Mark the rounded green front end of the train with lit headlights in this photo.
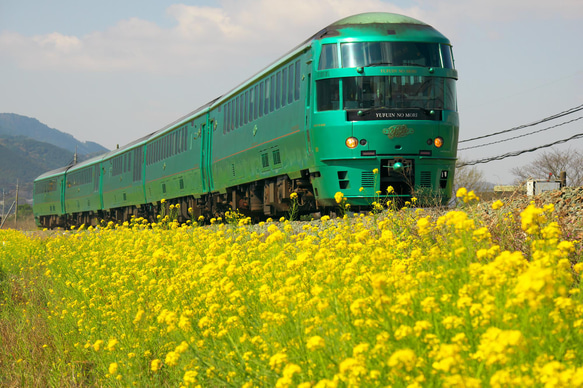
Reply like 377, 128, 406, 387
308, 13, 459, 206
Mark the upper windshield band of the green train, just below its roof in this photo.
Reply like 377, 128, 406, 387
340, 42, 453, 69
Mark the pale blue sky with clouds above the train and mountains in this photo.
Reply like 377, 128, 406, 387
0, 0, 583, 184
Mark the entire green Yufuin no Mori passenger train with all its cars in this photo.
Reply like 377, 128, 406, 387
34, 13, 459, 228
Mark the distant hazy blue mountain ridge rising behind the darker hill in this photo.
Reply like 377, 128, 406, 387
0, 113, 108, 155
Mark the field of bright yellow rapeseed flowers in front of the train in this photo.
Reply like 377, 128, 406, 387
0, 191, 583, 388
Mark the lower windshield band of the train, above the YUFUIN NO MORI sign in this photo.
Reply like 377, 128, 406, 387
317, 76, 457, 111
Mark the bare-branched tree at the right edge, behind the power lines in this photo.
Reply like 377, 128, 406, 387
510, 148, 583, 186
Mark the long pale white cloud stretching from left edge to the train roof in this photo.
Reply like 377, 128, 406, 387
0, 0, 420, 74
